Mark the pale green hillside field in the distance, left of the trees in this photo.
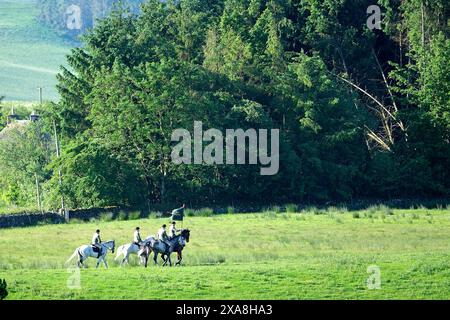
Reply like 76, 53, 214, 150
0, 0, 72, 101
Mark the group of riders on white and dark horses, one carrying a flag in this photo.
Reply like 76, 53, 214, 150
67, 205, 190, 267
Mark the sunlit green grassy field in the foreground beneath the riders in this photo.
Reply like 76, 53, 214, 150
0, 208, 450, 299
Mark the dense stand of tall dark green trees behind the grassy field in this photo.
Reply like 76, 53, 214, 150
1, 0, 450, 207
